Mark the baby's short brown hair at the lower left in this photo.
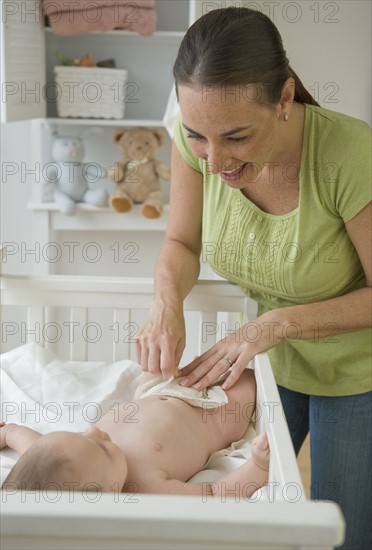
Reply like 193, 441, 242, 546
1, 445, 73, 491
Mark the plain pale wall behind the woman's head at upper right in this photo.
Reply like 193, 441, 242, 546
197, 0, 372, 123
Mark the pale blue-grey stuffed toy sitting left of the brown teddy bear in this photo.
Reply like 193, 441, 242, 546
43, 135, 108, 216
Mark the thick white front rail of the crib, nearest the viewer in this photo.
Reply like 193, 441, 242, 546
1, 492, 342, 550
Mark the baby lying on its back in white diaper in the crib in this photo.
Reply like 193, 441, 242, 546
0, 370, 269, 498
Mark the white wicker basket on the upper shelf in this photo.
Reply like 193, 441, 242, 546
54, 65, 128, 119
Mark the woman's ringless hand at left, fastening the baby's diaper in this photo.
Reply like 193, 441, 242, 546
136, 302, 186, 379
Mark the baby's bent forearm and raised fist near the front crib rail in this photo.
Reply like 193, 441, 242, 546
204, 433, 270, 500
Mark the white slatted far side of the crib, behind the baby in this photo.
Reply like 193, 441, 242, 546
1, 275, 256, 361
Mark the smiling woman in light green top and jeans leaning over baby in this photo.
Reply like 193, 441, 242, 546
137, 8, 372, 550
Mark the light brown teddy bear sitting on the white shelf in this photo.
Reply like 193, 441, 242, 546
108, 127, 170, 218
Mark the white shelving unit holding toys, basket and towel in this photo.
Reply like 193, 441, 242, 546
1, 0, 202, 275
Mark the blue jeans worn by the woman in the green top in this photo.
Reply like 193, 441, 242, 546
278, 386, 372, 550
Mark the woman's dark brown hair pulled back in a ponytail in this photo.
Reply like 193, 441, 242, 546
173, 7, 318, 105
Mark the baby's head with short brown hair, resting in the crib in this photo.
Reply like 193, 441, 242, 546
2, 427, 128, 492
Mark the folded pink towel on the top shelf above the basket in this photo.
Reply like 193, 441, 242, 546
43, 0, 157, 36
